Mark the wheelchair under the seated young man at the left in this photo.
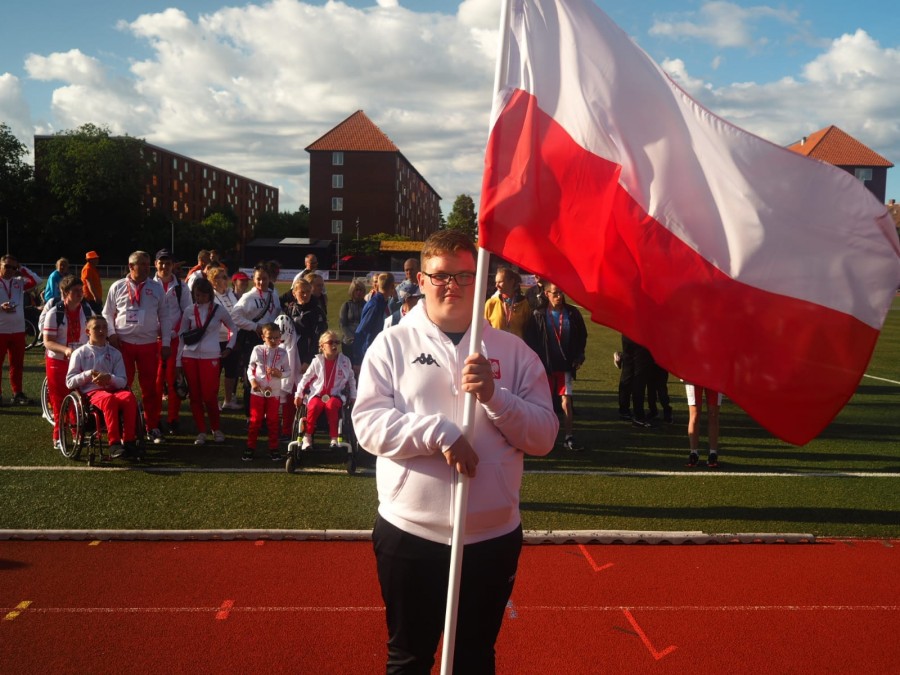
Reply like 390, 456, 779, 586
59, 391, 147, 466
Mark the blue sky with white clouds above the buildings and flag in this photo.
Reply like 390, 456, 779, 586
0, 0, 900, 214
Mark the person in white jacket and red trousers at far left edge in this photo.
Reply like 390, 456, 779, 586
0, 254, 40, 406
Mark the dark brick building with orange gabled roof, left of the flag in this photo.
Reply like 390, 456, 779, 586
306, 110, 441, 241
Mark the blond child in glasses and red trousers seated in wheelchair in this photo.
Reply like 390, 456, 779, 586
294, 330, 356, 450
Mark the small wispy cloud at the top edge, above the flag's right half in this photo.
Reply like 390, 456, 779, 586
650, 0, 796, 47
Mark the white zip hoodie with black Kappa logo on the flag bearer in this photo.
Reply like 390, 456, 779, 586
353, 303, 559, 544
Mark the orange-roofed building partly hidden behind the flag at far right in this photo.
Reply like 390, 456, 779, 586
788, 125, 894, 204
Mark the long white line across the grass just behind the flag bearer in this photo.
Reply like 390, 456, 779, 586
0, 466, 900, 478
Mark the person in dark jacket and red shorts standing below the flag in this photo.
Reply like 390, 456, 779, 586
526, 284, 587, 450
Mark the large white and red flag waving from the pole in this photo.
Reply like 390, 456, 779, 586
479, 0, 900, 444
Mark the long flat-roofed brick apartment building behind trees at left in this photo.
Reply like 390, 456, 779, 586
34, 136, 278, 252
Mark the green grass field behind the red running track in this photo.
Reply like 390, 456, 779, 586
0, 283, 900, 537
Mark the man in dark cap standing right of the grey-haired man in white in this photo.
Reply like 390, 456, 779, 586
154, 249, 191, 435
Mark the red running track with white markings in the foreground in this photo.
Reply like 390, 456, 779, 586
0, 540, 900, 675
